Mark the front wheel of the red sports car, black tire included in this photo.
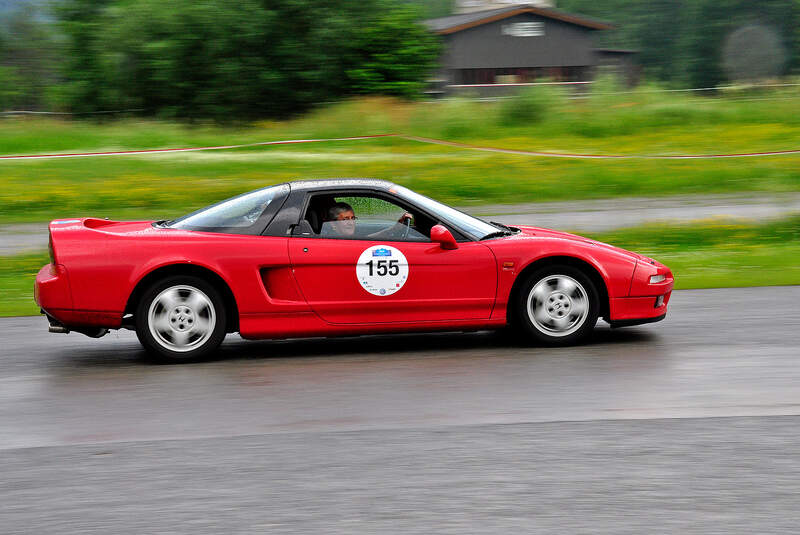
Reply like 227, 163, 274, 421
512, 265, 600, 346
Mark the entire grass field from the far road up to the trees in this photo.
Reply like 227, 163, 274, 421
0, 88, 800, 223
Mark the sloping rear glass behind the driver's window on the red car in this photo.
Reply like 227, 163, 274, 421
165, 184, 289, 230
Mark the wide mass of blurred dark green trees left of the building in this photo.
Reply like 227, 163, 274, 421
53, 0, 438, 120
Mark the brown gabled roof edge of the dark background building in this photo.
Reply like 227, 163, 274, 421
425, 4, 613, 35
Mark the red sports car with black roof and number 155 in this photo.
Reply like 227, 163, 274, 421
35, 179, 673, 361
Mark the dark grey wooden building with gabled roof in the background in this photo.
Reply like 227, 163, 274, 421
425, 0, 635, 95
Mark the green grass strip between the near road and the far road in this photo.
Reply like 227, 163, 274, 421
0, 216, 800, 316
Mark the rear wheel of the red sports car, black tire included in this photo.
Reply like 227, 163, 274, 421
135, 275, 227, 363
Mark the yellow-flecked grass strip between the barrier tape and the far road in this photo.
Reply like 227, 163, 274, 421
0, 140, 800, 223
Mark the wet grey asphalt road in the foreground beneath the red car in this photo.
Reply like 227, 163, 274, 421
0, 287, 800, 534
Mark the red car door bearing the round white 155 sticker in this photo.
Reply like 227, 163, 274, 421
289, 195, 497, 324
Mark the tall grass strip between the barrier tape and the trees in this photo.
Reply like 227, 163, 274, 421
0, 85, 800, 154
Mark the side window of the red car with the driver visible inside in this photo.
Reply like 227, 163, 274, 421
304, 194, 432, 242
